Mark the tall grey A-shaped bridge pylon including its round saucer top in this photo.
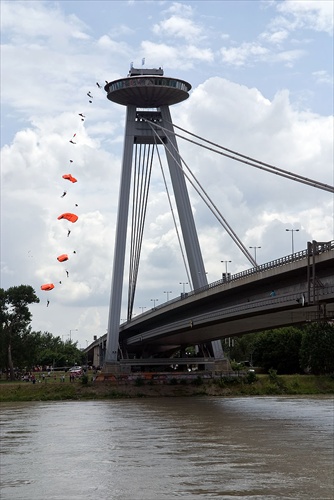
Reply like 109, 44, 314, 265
104, 67, 224, 371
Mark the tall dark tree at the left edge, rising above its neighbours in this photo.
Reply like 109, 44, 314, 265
0, 285, 39, 380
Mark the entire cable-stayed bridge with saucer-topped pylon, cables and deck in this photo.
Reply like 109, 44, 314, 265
89, 67, 334, 373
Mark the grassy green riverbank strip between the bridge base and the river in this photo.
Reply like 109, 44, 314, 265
0, 375, 334, 402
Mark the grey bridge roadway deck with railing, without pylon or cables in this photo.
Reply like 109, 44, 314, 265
86, 241, 334, 371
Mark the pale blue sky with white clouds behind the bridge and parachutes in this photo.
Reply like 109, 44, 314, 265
0, 0, 334, 347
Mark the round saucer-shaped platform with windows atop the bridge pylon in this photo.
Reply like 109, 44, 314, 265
104, 68, 191, 108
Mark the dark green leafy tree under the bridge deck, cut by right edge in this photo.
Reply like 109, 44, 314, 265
300, 322, 334, 375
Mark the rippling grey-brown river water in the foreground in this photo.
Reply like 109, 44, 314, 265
0, 397, 334, 500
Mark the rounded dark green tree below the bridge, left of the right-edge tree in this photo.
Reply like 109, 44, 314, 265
253, 326, 303, 373
